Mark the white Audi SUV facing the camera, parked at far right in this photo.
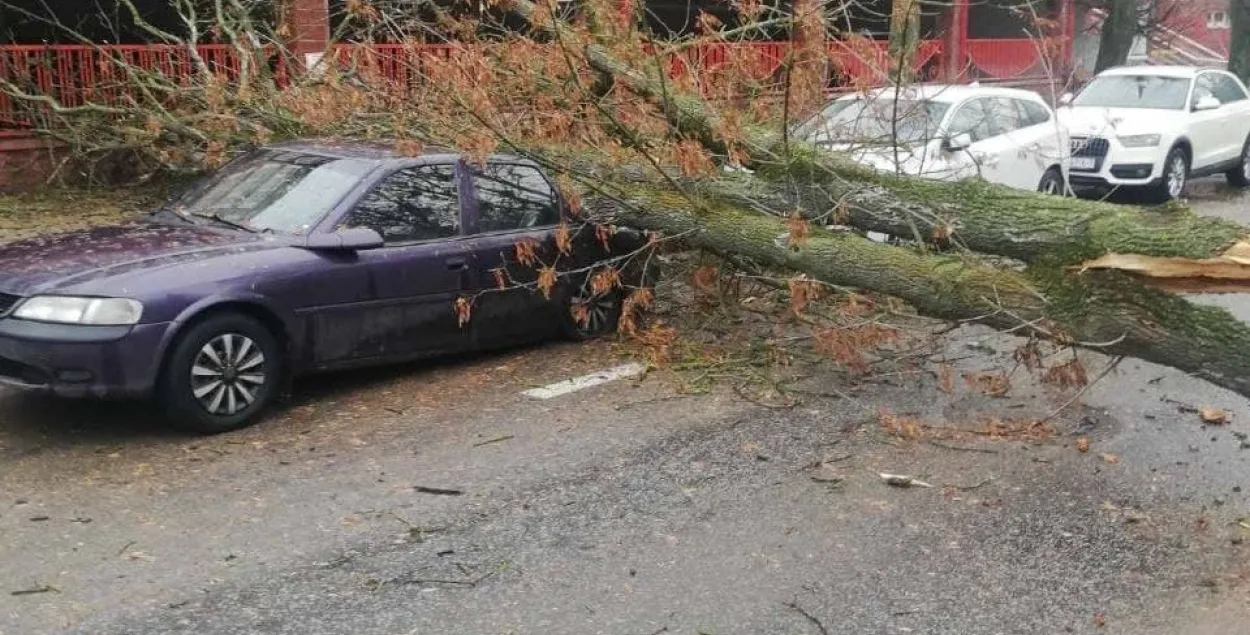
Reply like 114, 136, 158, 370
1059, 66, 1250, 199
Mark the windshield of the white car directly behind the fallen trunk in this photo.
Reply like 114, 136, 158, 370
800, 98, 950, 145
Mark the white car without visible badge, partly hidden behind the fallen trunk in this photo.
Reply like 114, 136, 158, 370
794, 84, 1069, 194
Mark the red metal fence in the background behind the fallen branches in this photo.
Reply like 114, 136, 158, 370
0, 39, 1046, 128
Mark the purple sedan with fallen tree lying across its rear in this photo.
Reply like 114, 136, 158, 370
0, 143, 654, 433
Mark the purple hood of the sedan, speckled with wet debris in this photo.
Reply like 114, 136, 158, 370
0, 220, 270, 296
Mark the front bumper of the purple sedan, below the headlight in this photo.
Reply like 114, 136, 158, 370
0, 319, 170, 398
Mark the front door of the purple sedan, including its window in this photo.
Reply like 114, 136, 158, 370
314, 163, 471, 366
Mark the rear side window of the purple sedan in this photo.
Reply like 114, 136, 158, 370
473, 164, 560, 231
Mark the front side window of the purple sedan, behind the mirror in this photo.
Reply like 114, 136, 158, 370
343, 164, 460, 245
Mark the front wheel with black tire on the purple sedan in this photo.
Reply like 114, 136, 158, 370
158, 313, 285, 434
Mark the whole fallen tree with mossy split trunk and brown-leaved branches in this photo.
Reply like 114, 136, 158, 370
7, 0, 1250, 395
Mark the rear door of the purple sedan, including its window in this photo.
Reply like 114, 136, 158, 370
466, 159, 567, 348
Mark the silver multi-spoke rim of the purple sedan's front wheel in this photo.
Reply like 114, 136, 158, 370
190, 334, 268, 416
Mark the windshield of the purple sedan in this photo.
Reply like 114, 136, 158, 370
173, 150, 374, 234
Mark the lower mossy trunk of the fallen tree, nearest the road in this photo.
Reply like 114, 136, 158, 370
584, 184, 1250, 395
